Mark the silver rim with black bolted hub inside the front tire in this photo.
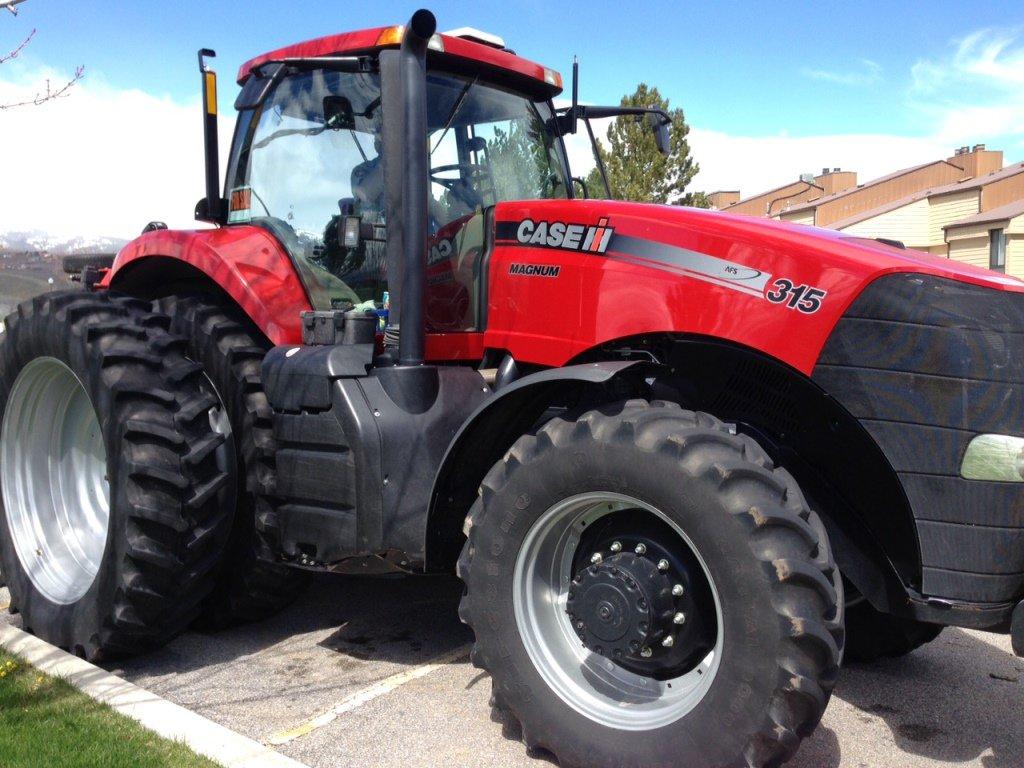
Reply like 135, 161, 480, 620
513, 492, 723, 730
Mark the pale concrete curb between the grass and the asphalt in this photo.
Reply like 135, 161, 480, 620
0, 627, 306, 768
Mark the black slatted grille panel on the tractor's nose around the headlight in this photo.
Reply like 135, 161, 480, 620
813, 274, 1024, 602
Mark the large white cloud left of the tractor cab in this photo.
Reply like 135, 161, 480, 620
0, 62, 233, 238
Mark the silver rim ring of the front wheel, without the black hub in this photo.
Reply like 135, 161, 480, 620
513, 493, 723, 730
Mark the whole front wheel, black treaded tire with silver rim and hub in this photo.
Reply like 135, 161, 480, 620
459, 400, 844, 768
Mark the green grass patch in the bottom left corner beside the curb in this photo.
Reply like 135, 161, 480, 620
0, 650, 217, 768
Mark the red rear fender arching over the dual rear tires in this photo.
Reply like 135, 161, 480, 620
97, 226, 312, 344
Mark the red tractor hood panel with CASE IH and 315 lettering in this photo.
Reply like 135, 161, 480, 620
484, 201, 1024, 374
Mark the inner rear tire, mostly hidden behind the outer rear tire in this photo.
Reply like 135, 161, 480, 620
159, 296, 306, 630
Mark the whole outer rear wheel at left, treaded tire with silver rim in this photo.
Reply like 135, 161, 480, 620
0, 291, 234, 659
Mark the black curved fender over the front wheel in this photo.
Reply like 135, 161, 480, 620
424, 360, 657, 570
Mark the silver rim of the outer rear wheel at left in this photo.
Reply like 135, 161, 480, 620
0, 357, 111, 605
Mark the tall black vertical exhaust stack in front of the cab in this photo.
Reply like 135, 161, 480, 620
380, 9, 437, 366
